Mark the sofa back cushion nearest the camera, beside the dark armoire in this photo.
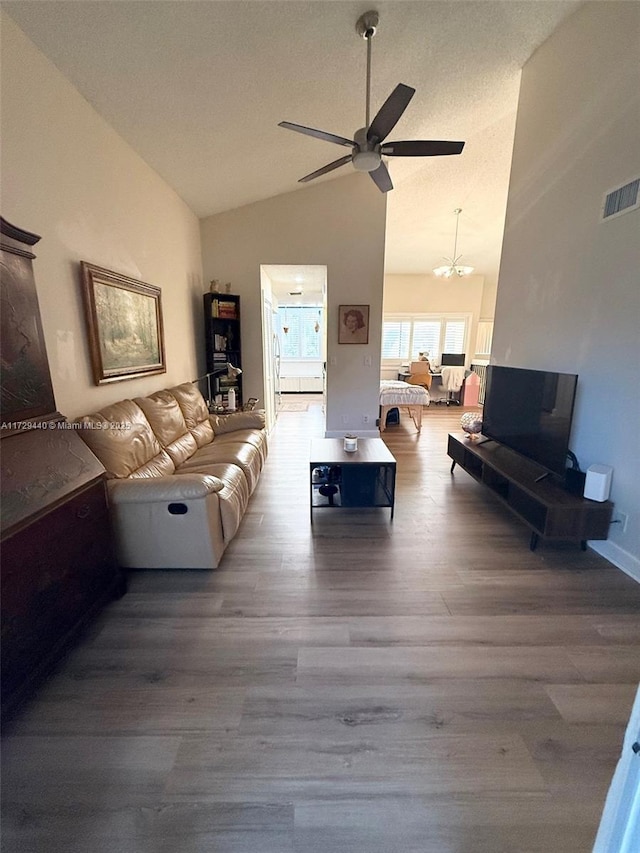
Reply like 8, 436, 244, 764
76, 400, 175, 479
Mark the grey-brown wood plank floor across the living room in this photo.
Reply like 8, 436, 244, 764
2, 397, 640, 853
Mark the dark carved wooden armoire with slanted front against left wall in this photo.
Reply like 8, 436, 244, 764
0, 217, 124, 720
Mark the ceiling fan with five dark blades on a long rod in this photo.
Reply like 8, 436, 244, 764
278, 11, 464, 193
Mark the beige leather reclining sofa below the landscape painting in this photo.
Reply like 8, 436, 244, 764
76, 383, 267, 569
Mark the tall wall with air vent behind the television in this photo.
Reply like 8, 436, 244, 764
492, 2, 640, 579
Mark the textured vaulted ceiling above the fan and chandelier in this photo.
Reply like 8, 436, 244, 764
2, 0, 580, 288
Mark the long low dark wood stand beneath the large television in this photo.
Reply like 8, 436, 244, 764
447, 433, 613, 551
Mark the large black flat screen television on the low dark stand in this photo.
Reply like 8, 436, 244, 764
482, 365, 578, 477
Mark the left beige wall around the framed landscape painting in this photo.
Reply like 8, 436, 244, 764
1, 14, 204, 417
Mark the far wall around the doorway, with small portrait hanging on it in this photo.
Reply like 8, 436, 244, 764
202, 173, 386, 435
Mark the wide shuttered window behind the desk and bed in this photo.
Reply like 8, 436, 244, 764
382, 314, 470, 362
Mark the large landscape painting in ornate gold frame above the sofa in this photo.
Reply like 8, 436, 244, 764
80, 261, 167, 385
